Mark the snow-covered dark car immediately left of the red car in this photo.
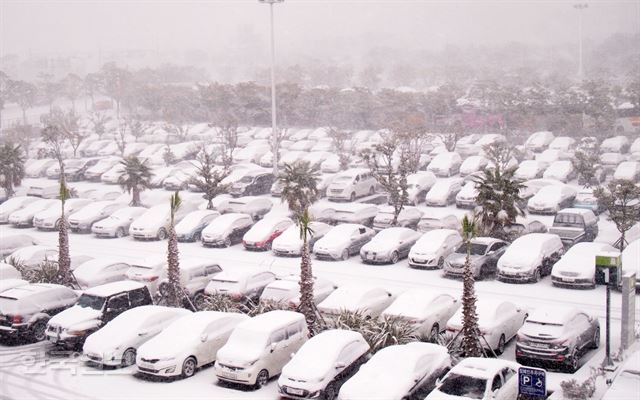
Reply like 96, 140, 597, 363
201, 213, 253, 247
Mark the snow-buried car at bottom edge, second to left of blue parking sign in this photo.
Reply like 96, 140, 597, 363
338, 342, 451, 400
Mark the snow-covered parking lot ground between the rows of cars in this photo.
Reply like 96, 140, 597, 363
0, 180, 640, 400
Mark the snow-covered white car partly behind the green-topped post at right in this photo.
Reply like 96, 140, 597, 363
551, 242, 616, 288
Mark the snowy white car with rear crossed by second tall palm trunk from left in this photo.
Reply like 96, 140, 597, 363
129, 201, 198, 240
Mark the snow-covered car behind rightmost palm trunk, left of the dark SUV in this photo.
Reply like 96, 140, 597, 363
447, 298, 528, 355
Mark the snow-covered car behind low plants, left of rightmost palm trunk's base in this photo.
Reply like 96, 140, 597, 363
381, 289, 460, 340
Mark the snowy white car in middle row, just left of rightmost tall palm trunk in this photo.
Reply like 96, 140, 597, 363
409, 229, 462, 269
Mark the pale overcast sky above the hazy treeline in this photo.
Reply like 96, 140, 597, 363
0, 0, 640, 55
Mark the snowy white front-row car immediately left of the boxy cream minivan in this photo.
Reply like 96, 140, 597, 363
136, 311, 249, 378
